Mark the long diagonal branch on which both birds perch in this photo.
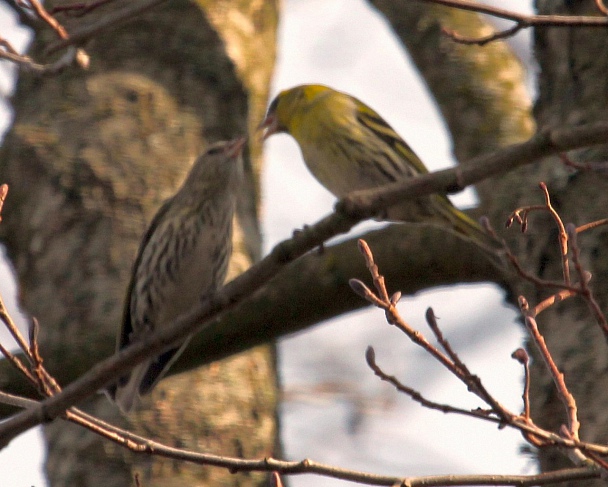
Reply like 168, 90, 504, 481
0, 123, 608, 445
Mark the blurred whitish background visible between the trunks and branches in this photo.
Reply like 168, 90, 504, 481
0, 0, 535, 487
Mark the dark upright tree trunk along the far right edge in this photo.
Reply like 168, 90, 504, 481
518, 0, 608, 485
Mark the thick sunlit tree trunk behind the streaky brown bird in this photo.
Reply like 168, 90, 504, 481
0, 1, 277, 486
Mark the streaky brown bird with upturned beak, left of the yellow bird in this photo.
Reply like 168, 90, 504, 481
107, 138, 245, 412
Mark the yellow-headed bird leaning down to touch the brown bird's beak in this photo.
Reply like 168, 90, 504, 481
259, 85, 491, 248
